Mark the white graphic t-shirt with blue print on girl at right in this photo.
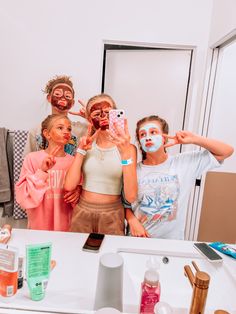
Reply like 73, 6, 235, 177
132, 150, 220, 239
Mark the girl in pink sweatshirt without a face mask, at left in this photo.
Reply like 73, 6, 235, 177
15, 114, 79, 231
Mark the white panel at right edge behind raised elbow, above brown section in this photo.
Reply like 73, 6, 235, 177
208, 41, 236, 173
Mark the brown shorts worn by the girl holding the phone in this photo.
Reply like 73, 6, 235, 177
70, 197, 125, 235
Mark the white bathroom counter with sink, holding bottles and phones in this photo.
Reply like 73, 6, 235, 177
0, 229, 236, 314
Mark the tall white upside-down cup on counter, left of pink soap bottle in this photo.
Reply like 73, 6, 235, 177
94, 253, 123, 312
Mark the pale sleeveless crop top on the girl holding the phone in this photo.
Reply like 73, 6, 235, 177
83, 143, 122, 195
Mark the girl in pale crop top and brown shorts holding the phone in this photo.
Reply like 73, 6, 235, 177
64, 94, 137, 235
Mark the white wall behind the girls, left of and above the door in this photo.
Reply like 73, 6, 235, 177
0, 0, 212, 129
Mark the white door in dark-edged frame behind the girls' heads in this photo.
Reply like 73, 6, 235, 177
102, 45, 192, 157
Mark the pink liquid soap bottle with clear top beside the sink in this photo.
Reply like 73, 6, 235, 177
140, 257, 161, 314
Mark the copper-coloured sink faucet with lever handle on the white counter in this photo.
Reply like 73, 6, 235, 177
184, 262, 210, 314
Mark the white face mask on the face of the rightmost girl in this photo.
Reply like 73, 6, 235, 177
139, 123, 163, 153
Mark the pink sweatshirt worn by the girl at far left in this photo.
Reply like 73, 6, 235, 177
15, 150, 74, 231
